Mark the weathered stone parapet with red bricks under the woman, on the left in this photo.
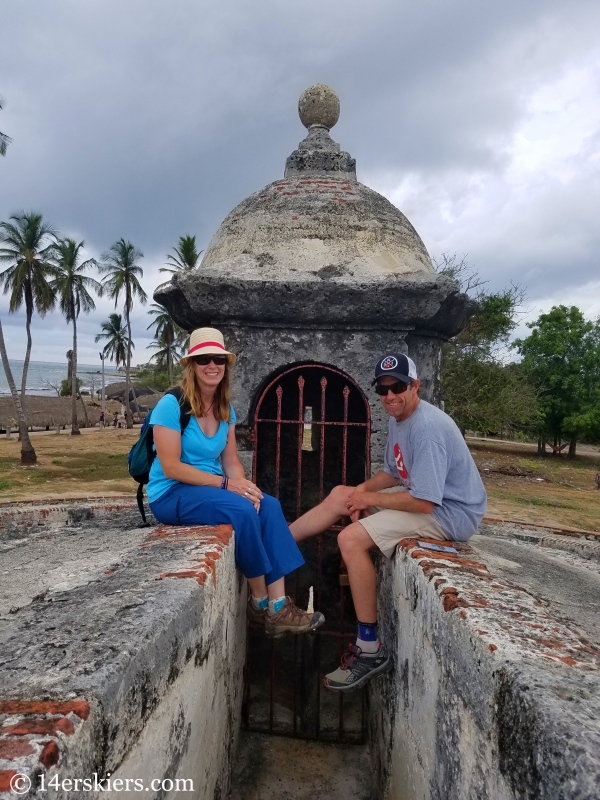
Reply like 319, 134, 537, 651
0, 515, 245, 800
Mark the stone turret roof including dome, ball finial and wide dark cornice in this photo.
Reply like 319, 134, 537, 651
154, 84, 469, 337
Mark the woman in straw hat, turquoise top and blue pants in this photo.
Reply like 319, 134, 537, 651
147, 328, 325, 636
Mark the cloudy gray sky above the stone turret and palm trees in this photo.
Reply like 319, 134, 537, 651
0, 0, 600, 363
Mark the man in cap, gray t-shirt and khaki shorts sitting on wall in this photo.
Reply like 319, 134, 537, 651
290, 353, 486, 692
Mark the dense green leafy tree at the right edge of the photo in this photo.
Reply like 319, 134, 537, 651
514, 305, 600, 458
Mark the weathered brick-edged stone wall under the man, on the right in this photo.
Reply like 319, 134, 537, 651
370, 539, 600, 800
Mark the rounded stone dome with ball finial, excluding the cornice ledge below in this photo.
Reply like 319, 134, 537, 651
199, 85, 435, 282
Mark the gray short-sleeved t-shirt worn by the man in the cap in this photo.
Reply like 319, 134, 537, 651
384, 400, 487, 542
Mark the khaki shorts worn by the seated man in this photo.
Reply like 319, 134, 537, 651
359, 486, 449, 558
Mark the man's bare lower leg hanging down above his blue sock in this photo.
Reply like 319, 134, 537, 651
338, 522, 377, 623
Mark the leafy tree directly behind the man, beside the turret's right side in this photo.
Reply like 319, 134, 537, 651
436, 255, 537, 434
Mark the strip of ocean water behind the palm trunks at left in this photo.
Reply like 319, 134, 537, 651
0, 359, 124, 397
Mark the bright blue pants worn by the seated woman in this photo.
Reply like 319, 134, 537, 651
150, 483, 304, 585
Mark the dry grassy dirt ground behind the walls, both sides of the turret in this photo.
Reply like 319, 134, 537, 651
0, 427, 600, 531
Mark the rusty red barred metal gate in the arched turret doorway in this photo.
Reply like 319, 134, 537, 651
244, 364, 371, 742
